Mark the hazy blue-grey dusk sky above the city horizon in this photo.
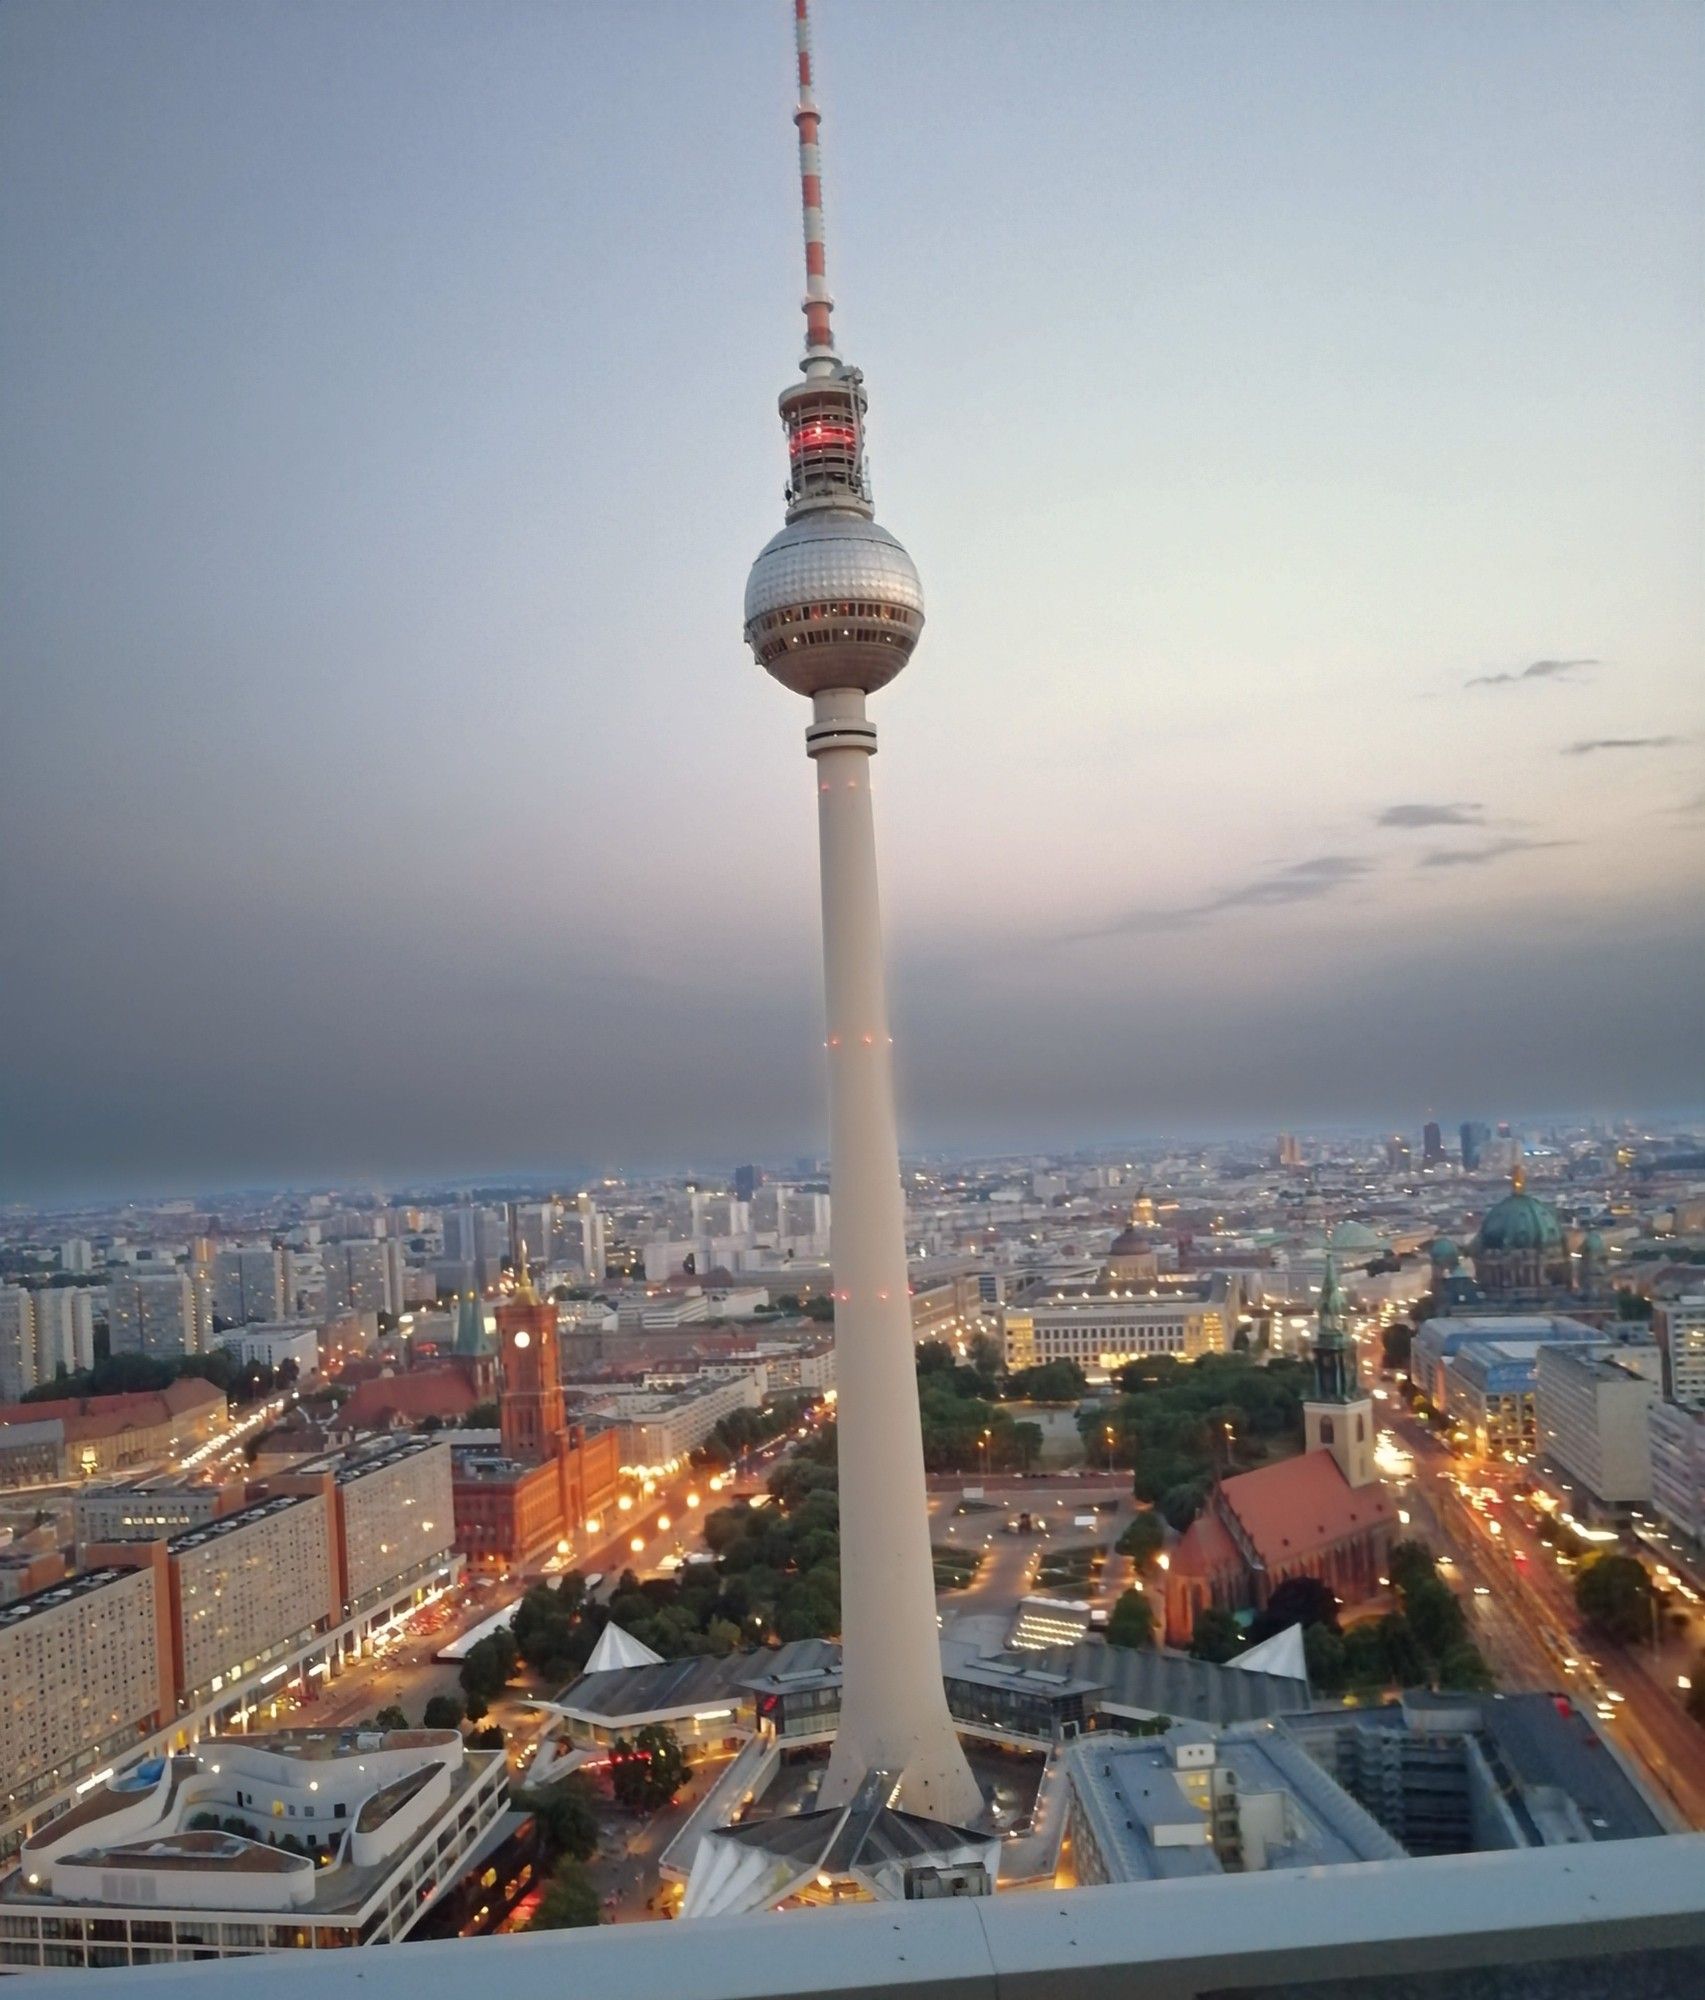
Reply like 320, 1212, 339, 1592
0, 0, 1705, 1198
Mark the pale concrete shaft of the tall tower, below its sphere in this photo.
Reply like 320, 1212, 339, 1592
806, 688, 983, 1822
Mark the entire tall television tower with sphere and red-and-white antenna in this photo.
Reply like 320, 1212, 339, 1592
746, 0, 983, 1824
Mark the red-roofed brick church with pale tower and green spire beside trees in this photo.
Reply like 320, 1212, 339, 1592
1167, 1256, 1397, 1646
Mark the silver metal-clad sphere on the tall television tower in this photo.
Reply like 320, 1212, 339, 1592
746, 508, 923, 694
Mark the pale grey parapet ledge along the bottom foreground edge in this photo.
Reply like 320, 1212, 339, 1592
40, 1834, 1705, 2000
